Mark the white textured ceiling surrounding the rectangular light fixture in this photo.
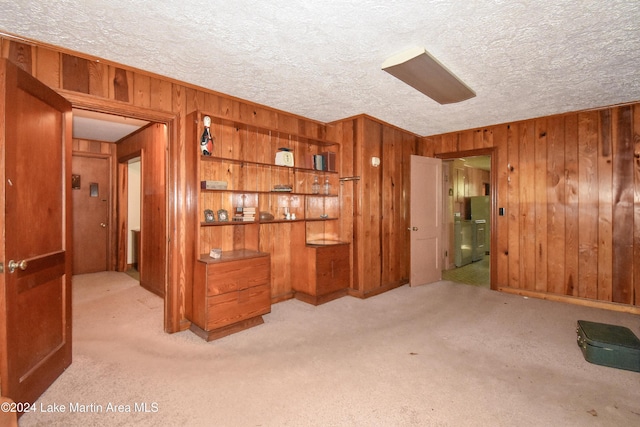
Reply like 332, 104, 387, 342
0, 0, 640, 135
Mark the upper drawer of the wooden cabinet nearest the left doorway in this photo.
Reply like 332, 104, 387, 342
207, 257, 270, 296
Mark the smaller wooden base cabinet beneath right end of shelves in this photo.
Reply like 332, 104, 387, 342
293, 241, 351, 305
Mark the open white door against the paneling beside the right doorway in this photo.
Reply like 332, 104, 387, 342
409, 156, 442, 286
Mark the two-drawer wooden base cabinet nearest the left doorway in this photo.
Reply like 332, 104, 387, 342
190, 250, 271, 341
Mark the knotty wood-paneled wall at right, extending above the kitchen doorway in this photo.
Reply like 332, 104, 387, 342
424, 104, 640, 306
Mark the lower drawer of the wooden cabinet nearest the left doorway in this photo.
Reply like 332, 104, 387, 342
205, 283, 271, 330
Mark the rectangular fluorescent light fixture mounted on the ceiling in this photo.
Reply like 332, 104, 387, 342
382, 48, 476, 104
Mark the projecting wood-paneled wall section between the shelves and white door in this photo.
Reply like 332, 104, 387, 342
333, 115, 422, 297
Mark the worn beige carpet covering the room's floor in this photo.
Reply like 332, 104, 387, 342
20, 272, 640, 427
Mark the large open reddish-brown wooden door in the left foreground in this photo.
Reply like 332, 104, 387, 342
0, 60, 71, 412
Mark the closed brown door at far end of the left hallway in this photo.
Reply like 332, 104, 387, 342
71, 155, 111, 274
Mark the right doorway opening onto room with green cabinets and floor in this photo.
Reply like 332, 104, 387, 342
442, 153, 492, 288
